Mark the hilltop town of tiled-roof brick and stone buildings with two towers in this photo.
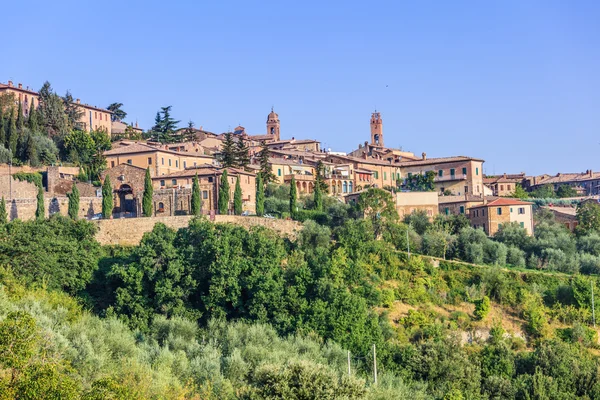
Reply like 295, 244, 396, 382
0, 81, 600, 236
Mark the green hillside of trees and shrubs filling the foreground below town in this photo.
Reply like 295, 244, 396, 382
0, 198, 600, 399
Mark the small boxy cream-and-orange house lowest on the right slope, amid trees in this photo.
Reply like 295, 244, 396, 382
469, 198, 533, 236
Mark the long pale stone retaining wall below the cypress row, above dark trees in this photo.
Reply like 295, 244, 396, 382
95, 215, 302, 246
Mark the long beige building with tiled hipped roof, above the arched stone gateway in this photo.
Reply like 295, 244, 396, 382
104, 143, 214, 176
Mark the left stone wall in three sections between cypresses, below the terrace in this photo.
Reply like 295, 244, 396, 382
5, 197, 102, 221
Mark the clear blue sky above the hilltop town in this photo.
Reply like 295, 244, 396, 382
0, 0, 600, 174
